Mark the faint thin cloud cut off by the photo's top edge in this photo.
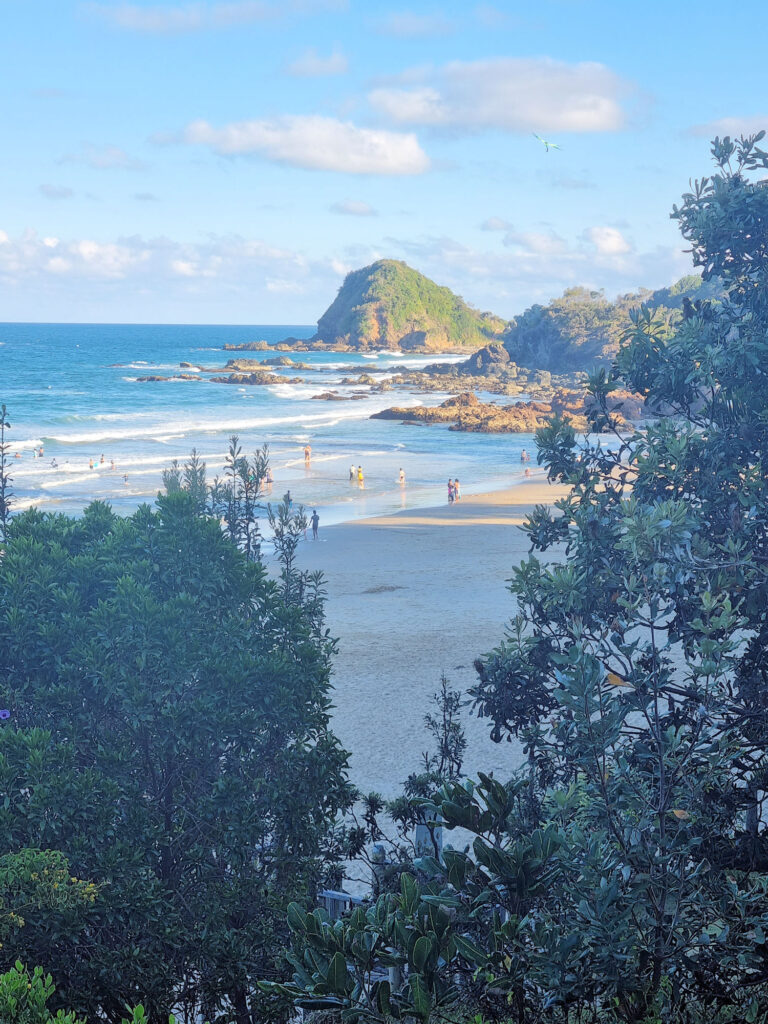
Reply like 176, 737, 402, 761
83, 0, 346, 35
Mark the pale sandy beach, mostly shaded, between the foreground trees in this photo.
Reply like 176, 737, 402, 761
299, 476, 564, 797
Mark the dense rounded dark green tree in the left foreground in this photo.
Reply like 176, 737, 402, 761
0, 488, 349, 1024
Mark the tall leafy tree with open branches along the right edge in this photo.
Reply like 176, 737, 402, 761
280, 133, 768, 1024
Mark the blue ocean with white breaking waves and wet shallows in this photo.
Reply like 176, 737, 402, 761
0, 324, 535, 525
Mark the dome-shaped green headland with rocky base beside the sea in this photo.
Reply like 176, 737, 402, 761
311, 259, 508, 351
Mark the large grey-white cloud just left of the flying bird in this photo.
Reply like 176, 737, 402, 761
369, 57, 631, 132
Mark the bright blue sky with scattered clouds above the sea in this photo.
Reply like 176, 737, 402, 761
0, 0, 768, 325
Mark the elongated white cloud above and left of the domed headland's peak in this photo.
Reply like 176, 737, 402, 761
181, 116, 429, 174
